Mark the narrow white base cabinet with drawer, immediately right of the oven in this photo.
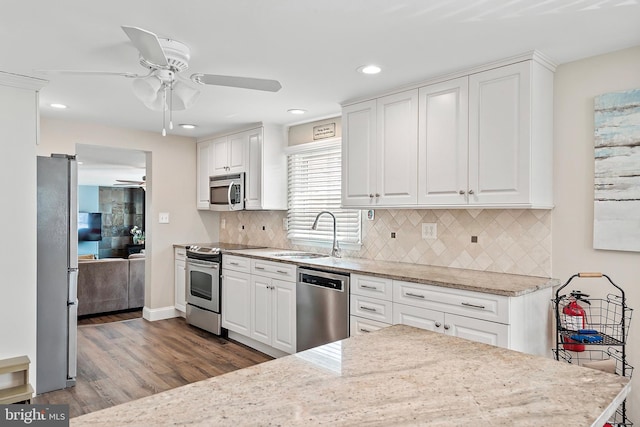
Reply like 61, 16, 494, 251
221, 255, 251, 335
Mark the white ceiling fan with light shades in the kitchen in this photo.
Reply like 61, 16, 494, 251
41, 26, 282, 136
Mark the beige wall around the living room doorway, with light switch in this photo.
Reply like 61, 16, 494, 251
37, 119, 218, 318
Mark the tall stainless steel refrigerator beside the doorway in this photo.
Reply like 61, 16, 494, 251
36, 154, 78, 394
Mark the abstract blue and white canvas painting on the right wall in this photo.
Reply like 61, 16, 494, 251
593, 89, 640, 252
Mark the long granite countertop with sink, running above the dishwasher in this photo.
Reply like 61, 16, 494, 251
223, 248, 560, 297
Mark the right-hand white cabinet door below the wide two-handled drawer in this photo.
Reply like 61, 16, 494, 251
444, 313, 509, 348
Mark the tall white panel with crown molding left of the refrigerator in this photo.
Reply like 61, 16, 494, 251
0, 72, 46, 392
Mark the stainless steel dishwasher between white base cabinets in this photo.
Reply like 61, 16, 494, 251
296, 267, 349, 351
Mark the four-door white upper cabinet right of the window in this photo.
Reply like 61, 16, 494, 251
343, 53, 554, 208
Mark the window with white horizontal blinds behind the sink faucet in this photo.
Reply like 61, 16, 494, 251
287, 140, 360, 249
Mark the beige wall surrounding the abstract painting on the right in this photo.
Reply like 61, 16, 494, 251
552, 46, 640, 423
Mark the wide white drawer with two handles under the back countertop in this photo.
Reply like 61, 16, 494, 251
393, 281, 509, 324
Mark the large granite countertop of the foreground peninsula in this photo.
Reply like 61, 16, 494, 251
71, 325, 630, 427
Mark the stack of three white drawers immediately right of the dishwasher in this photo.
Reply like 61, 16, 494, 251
349, 273, 393, 336
